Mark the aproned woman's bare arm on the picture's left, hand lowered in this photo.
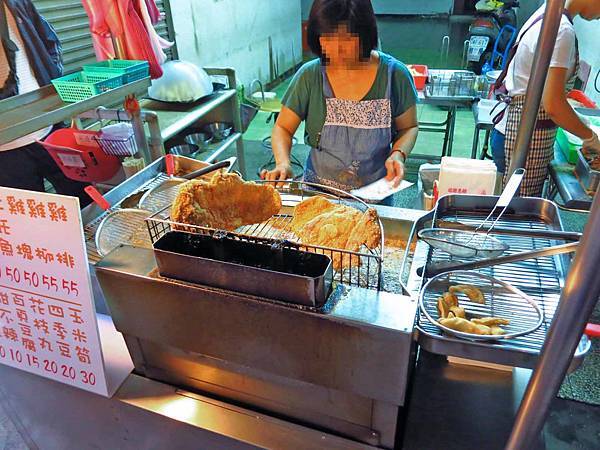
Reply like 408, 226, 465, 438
260, 106, 302, 184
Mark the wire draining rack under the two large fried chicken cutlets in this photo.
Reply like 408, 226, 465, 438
146, 181, 384, 290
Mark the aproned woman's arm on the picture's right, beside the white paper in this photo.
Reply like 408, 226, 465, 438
385, 105, 419, 186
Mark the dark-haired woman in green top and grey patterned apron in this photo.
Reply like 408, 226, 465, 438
261, 0, 418, 204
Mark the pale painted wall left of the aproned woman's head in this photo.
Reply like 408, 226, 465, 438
171, 0, 302, 86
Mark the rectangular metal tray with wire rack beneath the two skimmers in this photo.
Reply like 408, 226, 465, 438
408, 196, 590, 368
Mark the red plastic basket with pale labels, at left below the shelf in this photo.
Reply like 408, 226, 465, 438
40, 128, 121, 183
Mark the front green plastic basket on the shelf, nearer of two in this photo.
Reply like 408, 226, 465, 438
52, 72, 123, 102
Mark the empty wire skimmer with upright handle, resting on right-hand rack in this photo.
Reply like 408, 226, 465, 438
418, 169, 525, 258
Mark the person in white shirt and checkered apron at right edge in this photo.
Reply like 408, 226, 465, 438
491, 0, 600, 196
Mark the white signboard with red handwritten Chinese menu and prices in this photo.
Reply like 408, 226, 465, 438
0, 187, 108, 395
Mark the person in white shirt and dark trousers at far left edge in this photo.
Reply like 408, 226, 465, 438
0, 0, 90, 206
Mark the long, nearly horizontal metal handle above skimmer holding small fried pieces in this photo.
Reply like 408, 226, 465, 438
417, 242, 579, 278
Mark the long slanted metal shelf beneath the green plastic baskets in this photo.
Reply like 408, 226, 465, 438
0, 78, 150, 145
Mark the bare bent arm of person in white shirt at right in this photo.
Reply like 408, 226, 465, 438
543, 67, 595, 140
